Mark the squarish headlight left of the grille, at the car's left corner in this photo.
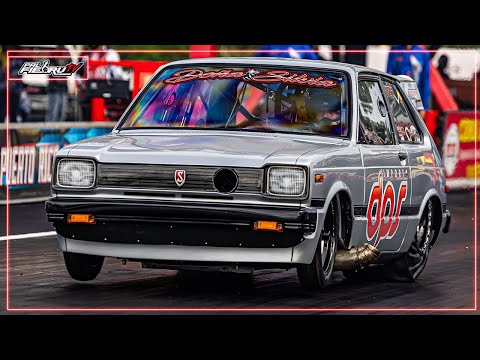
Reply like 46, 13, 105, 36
57, 159, 95, 188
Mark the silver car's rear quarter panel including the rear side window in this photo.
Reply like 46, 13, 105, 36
382, 78, 441, 219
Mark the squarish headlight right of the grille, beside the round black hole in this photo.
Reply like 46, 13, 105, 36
267, 166, 307, 196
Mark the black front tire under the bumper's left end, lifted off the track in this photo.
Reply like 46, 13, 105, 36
63, 252, 105, 281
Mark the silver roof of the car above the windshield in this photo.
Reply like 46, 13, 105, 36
165, 57, 398, 80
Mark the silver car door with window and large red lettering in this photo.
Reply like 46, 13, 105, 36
357, 76, 411, 251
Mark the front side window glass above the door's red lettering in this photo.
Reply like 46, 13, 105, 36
358, 80, 393, 145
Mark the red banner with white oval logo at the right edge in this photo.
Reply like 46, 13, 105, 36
443, 112, 480, 181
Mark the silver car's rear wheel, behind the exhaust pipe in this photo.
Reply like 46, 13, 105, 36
385, 199, 435, 282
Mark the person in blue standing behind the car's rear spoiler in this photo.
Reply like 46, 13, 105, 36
387, 45, 431, 109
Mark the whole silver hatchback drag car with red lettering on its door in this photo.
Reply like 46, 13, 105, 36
46, 58, 451, 289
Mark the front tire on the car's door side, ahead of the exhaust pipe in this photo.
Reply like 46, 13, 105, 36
297, 201, 339, 290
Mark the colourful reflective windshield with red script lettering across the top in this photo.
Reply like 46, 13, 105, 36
121, 66, 349, 137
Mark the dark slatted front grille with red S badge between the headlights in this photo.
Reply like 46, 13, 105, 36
98, 163, 263, 194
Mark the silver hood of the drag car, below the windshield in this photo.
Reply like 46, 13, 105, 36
65, 130, 343, 167
